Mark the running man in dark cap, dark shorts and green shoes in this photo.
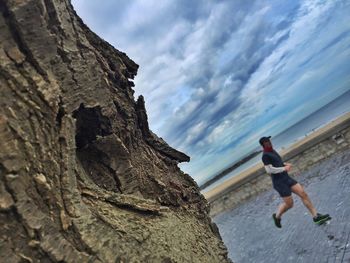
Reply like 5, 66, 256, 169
259, 136, 331, 228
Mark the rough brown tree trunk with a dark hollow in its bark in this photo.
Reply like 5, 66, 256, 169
0, 0, 229, 262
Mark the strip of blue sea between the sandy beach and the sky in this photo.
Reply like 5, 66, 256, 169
201, 90, 350, 193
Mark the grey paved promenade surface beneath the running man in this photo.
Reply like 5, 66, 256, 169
214, 150, 350, 263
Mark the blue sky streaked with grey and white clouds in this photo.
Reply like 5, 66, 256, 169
72, 0, 350, 184
